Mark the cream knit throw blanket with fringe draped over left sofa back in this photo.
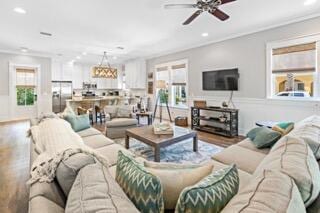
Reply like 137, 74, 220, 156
28, 119, 109, 184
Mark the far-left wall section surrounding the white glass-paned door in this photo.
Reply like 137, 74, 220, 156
0, 53, 52, 121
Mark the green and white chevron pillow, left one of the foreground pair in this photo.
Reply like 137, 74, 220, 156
116, 151, 164, 213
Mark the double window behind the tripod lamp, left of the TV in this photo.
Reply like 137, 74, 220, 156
156, 60, 188, 108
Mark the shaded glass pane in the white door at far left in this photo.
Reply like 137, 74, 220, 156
16, 69, 36, 106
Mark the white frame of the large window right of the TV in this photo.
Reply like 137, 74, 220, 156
266, 34, 320, 101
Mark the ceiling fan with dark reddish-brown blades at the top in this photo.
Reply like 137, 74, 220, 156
164, 0, 236, 25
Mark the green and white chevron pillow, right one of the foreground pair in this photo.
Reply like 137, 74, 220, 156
175, 165, 239, 213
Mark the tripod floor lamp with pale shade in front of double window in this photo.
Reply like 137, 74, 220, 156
153, 80, 172, 122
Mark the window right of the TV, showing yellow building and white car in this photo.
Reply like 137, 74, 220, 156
268, 39, 319, 99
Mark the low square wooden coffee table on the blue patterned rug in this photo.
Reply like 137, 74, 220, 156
126, 126, 198, 162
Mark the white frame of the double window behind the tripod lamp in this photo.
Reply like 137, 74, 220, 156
153, 59, 189, 109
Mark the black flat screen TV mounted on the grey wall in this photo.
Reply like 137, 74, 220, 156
202, 68, 239, 91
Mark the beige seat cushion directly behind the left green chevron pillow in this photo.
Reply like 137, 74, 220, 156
96, 144, 134, 166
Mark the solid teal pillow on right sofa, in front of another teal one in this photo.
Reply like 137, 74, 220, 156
252, 127, 281, 149
